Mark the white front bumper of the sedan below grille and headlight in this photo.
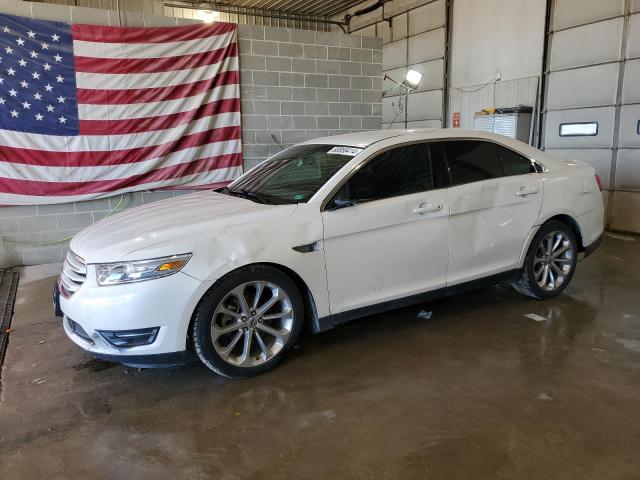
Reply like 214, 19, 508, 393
54, 272, 207, 367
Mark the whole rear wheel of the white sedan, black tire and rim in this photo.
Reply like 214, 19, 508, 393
513, 220, 578, 299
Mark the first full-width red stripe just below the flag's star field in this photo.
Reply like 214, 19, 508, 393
0, 126, 242, 167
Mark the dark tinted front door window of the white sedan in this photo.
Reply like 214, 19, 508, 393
345, 143, 434, 202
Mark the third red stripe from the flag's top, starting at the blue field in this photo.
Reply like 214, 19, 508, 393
77, 70, 240, 105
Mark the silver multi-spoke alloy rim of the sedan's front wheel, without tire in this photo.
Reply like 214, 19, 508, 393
211, 281, 293, 367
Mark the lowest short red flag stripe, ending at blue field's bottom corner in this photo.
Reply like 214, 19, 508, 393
79, 98, 240, 135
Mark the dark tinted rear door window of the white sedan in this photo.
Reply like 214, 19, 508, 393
433, 140, 504, 185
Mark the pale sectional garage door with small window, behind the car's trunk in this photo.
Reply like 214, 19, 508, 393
543, 0, 640, 232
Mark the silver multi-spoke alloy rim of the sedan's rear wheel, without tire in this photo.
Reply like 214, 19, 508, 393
533, 231, 575, 292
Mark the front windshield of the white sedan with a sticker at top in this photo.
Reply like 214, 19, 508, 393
220, 145, 362, 204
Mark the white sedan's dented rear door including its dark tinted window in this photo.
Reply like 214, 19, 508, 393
440, 140, 542, 285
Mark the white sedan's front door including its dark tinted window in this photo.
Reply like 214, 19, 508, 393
322, 143, 449, 314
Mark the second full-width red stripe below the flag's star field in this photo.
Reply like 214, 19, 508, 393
0, 153, 242, 196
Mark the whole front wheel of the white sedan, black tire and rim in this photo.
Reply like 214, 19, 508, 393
193, 265, 304, 378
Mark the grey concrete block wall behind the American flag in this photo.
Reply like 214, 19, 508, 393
0, 0, 382, 268
